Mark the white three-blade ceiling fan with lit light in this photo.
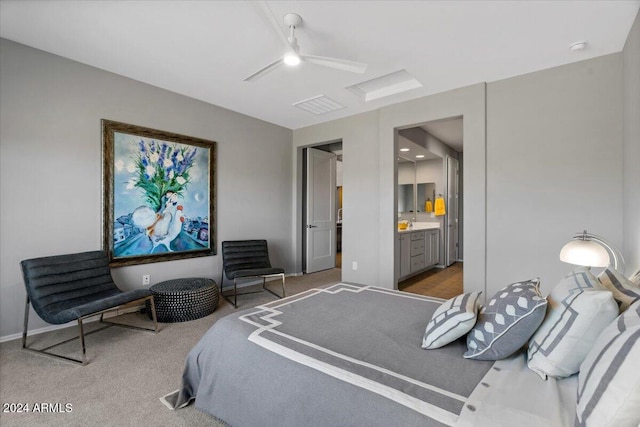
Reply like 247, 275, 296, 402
244, 10, 367, 82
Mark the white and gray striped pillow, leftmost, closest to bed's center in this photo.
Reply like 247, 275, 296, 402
422, 292, 482, 349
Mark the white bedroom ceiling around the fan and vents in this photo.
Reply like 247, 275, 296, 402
0, 0, 640, 129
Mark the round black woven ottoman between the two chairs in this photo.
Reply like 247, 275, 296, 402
146, 278, 219, 323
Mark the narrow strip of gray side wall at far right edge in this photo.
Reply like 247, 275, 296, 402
622, 13, 640, 275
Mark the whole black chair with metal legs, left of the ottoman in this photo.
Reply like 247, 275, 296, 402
20, 251, 158, 365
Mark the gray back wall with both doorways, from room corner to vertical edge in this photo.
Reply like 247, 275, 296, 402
293, 84, 485, 296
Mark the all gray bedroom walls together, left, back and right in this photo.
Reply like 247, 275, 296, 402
0, 18, 640, 336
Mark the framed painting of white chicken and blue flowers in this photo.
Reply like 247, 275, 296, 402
102, 119, 216, 266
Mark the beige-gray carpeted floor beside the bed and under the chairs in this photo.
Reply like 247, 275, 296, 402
0, 269, 341, 427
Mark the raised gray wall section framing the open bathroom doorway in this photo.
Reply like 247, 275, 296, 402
380, 83, 486, 291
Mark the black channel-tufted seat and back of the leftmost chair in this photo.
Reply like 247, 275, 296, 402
20, 251, 124, 324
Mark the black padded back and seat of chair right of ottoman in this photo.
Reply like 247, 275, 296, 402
222, 240, 271, 279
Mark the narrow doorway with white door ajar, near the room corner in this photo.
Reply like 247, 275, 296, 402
301, 141, 343, 274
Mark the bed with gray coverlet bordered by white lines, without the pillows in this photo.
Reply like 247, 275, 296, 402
162, 283, 588, 427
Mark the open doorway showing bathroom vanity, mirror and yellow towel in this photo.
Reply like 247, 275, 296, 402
396, 117, 464, 298
